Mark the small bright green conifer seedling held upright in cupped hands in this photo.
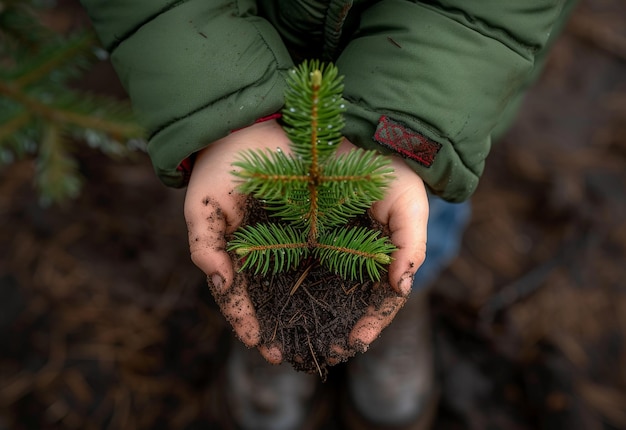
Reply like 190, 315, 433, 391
228, 61, 396, 281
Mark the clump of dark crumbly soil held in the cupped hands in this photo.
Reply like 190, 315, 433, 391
232, 198, 397, 379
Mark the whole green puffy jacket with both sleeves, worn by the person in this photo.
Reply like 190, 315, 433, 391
82, 0, 574, 201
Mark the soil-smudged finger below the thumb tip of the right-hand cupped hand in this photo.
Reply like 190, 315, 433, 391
349, 297, 407, 352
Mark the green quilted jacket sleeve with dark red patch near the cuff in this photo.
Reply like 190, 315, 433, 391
337, 0, 574, 202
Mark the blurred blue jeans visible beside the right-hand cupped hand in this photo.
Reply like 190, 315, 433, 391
413, 195, 471, 291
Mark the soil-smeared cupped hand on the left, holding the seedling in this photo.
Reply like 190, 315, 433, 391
185, 121, 289, 361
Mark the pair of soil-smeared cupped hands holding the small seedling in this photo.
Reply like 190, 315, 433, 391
185, 121, 428, 363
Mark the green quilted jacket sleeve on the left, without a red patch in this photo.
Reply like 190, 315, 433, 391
82, 0, 293, 187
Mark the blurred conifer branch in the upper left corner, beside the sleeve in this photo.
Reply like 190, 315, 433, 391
0, 0, 144, 204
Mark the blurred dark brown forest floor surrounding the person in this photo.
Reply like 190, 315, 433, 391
0, 0, 626, 430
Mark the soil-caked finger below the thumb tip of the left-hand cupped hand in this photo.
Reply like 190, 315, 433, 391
208, 277, 261, 347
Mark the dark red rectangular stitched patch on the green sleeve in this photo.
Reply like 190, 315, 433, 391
374, 115, 441, 167
